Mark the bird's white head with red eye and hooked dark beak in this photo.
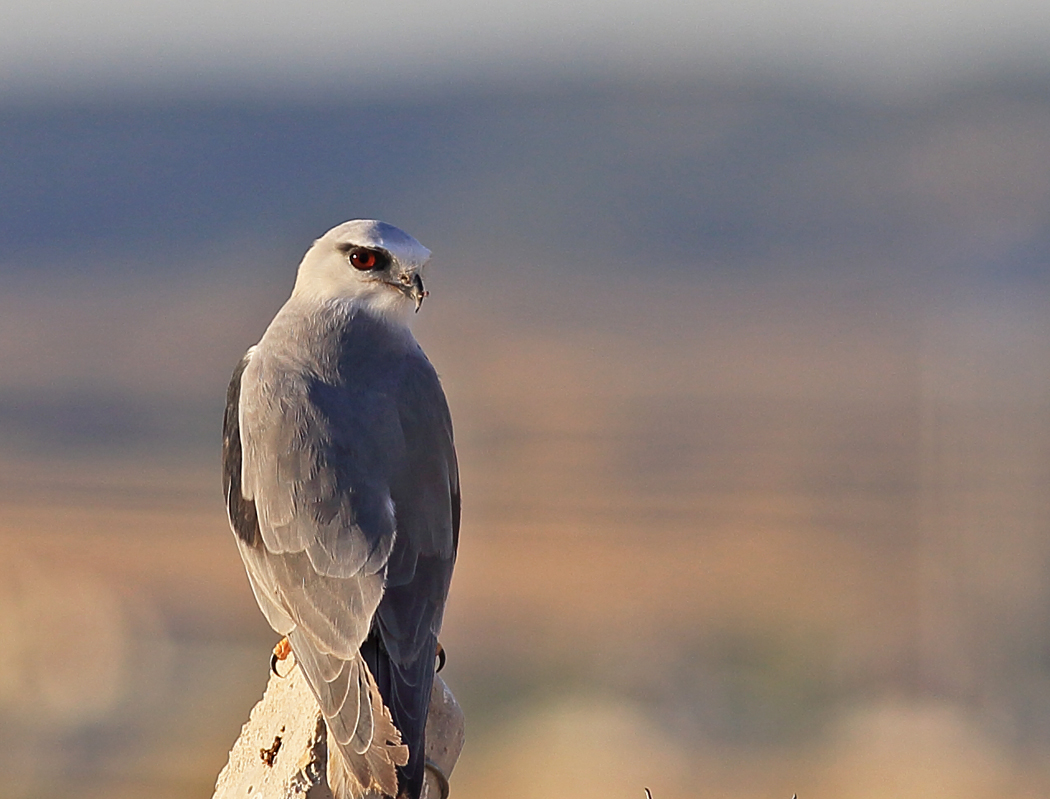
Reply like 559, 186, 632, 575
292, 219, 431, 321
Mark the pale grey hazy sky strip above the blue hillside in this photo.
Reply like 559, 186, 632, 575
6, 0, 1050, 96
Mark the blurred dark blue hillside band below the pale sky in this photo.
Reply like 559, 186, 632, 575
6, 82, 1050, 267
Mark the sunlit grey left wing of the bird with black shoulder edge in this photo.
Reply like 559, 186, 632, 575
223, 349, 394, 658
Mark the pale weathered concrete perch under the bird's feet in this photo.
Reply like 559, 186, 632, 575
212, 657, 464, 799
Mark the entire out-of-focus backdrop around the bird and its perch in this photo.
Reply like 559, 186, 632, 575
0, 0, 1050, 799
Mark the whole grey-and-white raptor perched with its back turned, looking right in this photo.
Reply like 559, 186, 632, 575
223, 219, 461, 799
